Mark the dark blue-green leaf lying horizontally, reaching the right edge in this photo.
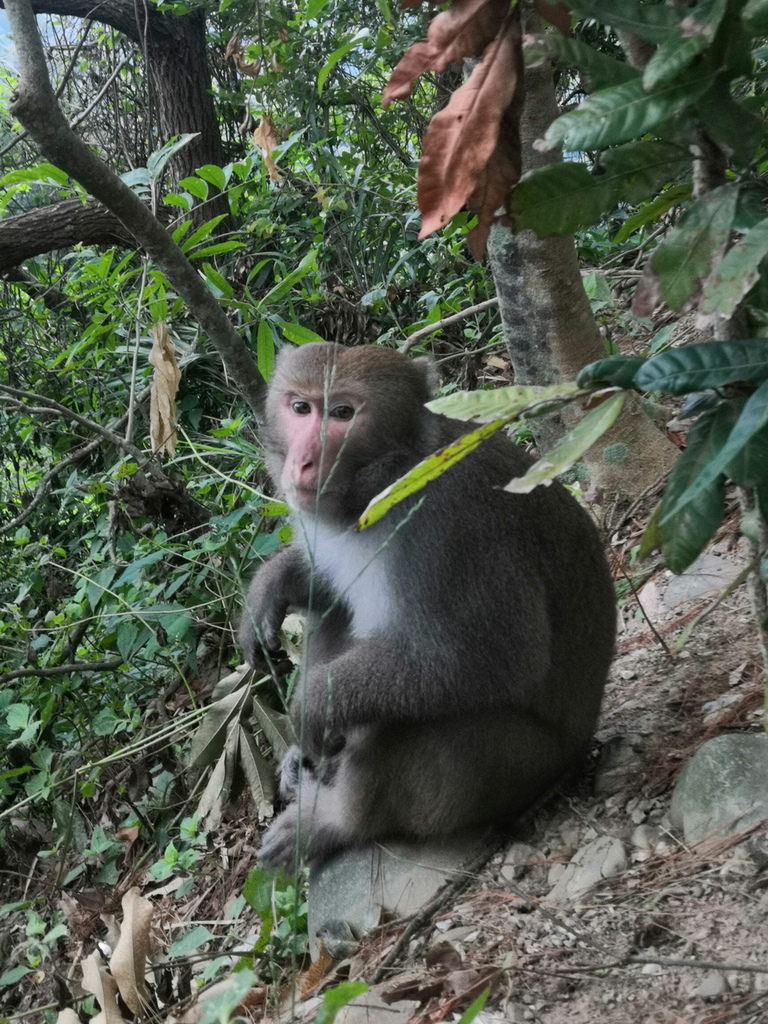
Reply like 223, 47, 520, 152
635, 338, 768, 394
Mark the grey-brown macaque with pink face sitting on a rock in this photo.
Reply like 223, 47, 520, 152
240, 343, 615, 867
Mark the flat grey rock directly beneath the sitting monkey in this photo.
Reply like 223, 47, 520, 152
308, 833, 484, 958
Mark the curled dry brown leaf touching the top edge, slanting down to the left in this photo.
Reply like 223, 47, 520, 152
382, 0, 509, 110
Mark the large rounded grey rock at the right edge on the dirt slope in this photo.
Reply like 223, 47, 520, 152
670, 733, 768, 843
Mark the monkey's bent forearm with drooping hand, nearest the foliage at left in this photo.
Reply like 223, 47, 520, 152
238, 545, 309, 662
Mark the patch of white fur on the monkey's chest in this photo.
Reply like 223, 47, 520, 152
297, 518, 394, 637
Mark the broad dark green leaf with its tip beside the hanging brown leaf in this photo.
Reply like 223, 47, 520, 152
510, 141, 690, 238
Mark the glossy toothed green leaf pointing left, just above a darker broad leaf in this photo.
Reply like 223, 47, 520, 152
544, 70, 714, 150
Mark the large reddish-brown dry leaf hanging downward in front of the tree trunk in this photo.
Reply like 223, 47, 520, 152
417, 17, 522, 256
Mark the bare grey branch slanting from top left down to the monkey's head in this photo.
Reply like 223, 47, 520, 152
4, 0, 266, 415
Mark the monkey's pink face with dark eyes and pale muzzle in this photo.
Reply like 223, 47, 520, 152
281, 392, 365, 512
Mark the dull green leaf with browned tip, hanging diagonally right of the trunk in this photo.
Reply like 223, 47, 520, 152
651, 184, 738, 309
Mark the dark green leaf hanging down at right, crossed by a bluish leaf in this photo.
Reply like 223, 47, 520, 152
659, 402, 738, 572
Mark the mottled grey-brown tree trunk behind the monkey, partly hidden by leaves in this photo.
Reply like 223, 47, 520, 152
488, 54, 677, 499
